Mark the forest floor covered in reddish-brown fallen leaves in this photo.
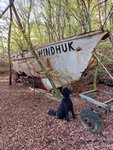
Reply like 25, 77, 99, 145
0, 66, 113, 150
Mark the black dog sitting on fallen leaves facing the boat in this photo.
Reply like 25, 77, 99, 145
48, 88, 76, 121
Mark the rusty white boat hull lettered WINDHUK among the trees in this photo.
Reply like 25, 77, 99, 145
12, 30, 108, 89
